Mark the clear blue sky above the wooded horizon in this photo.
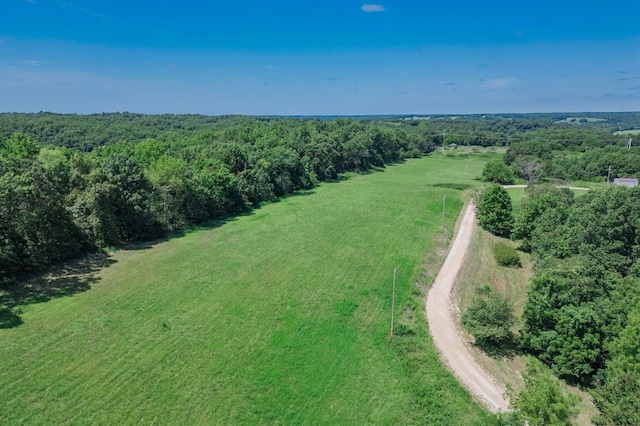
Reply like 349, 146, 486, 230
0, 0, 640, 115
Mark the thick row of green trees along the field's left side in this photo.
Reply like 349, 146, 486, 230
0, 119, 433, 285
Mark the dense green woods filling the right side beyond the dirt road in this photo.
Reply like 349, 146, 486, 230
512, 186, 640, 425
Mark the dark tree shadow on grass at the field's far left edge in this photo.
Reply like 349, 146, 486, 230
0, 252, 115, 328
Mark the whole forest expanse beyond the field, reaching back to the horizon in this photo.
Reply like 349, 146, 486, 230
0, 113, 640, 285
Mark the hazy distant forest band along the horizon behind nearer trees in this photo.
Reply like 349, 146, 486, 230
0, 112, 640, 155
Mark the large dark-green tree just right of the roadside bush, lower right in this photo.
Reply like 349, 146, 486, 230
521, 261, 610, 384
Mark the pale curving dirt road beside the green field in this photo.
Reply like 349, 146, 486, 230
426, 203, 509, 412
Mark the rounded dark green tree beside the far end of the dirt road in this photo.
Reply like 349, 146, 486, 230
476, 185, 513, 237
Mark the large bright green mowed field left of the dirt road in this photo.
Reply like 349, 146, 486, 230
0, 155, 496, 425
